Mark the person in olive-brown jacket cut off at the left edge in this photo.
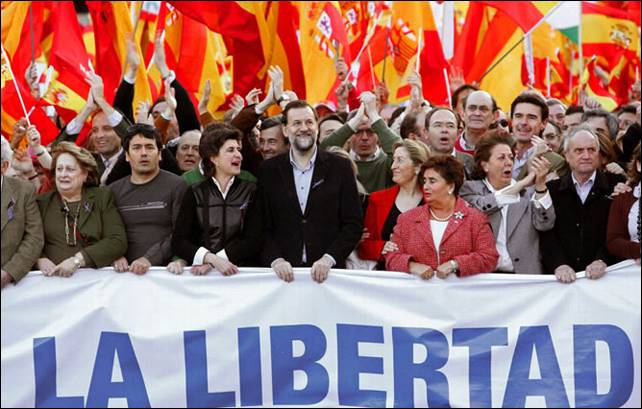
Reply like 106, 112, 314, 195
0, 144, 44, 288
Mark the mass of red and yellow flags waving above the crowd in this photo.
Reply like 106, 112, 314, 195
2, 1, 640, 142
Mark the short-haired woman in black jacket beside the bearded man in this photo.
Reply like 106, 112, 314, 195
172, 124, 259, 275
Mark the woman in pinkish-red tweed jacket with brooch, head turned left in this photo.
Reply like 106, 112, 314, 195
386, 155, 499, 280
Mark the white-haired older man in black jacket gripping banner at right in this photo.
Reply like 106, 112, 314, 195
541, 125, 624, 283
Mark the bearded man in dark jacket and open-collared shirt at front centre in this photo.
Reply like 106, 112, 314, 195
257, 101, 363, 283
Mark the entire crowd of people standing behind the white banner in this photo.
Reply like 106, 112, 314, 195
2, 43, 641, 288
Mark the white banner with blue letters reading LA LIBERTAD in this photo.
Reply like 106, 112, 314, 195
1, 262, 641, 407
